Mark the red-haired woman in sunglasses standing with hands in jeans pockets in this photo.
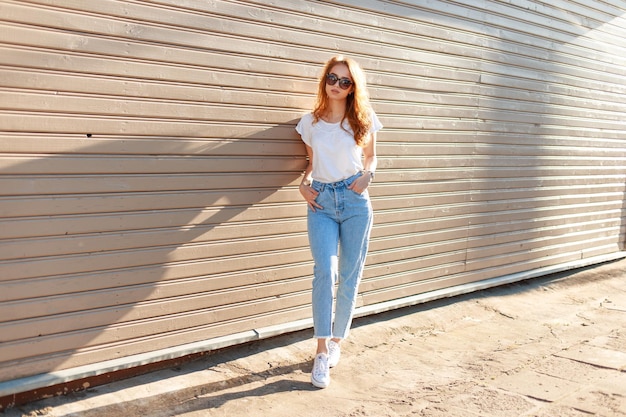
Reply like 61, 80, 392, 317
296, 56, 382, 388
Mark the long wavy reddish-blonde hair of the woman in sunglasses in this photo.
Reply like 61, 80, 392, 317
313, 55, 372, 146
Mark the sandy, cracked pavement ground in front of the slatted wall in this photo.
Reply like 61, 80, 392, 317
5, 260, 626, 417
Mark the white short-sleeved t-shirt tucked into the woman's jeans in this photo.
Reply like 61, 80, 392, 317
296, 111, 383, 183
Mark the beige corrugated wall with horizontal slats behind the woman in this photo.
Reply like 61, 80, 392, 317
0, 0, 626, 390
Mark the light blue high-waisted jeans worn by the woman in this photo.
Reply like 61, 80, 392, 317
307, 173, 373, 339
